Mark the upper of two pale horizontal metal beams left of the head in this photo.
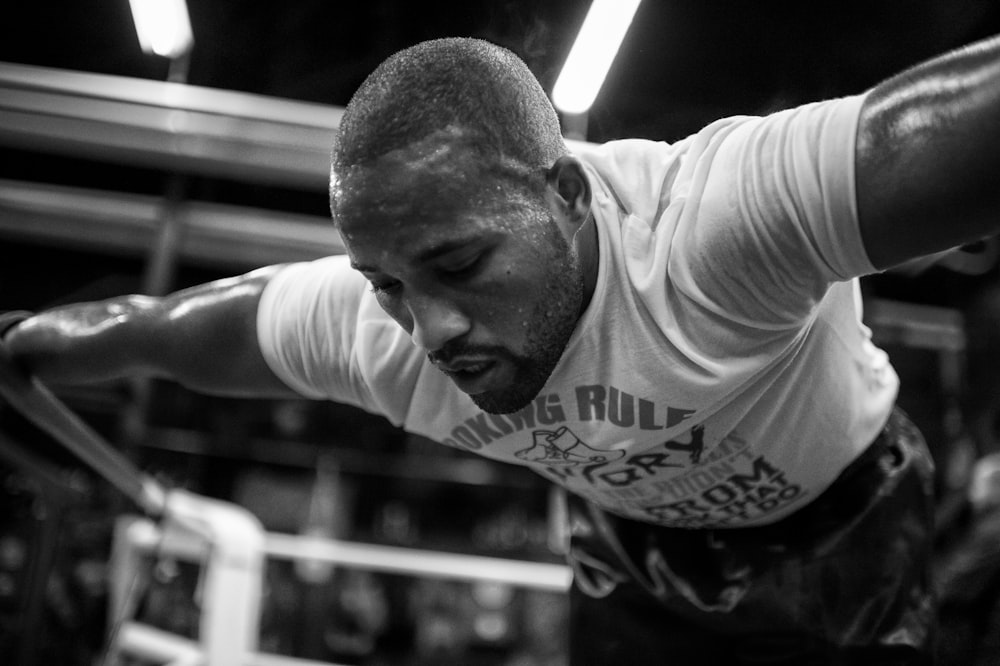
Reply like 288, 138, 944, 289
0, 63, 343, 191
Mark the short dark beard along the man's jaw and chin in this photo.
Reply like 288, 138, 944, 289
458, 228, 584, 414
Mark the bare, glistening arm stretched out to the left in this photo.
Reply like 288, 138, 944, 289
4, 267, 293, 397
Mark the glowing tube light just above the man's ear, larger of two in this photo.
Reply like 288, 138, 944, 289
552, 0, 640, 113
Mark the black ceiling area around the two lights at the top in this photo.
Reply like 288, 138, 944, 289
0, 0, 1000, 141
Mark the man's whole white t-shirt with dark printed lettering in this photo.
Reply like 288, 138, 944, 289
258, 97, 898, 527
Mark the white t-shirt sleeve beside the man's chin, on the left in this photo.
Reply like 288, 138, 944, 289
257, 256, 422, 425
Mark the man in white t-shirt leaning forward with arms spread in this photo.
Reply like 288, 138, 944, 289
4, 39, 1000, 664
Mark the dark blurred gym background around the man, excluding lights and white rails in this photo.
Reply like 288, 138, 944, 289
0, 0, 1000, 666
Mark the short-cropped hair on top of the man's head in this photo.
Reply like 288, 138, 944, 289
330, 38, 566, 213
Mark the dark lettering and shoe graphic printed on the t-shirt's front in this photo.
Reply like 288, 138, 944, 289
440, 385, 807, 527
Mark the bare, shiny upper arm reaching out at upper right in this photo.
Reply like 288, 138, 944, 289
856, 31, 1000, 269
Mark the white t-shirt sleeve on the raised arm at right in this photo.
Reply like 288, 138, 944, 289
670, 96, 875, 326
